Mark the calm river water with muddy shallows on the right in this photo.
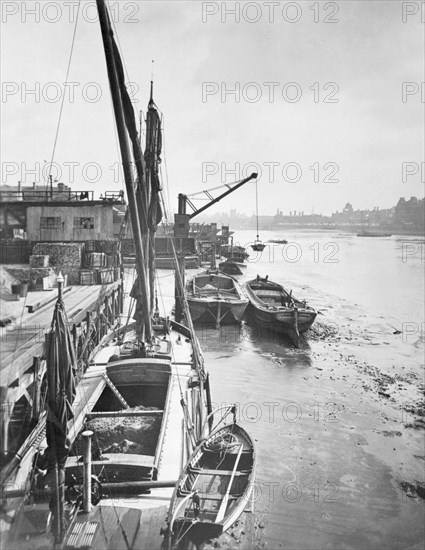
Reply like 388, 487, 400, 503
159, 231, 425, 550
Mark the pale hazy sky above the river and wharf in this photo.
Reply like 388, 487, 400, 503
1, 0, 425, 215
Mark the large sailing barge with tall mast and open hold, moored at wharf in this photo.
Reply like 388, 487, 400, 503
2, 0, 212, 550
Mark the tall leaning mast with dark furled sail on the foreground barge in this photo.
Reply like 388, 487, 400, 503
96, 0, 152, 342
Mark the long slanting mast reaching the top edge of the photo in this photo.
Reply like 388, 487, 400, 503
96, 0, 152, 341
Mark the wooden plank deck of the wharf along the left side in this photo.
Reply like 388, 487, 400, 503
0, 281, 124, 477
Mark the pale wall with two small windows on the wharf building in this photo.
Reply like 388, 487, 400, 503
27, 203, 114, 241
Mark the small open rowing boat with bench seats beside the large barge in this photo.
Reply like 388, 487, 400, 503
165, 407, 255, 549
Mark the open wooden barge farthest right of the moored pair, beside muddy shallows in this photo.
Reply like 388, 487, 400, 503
244, 276, 317, 346
